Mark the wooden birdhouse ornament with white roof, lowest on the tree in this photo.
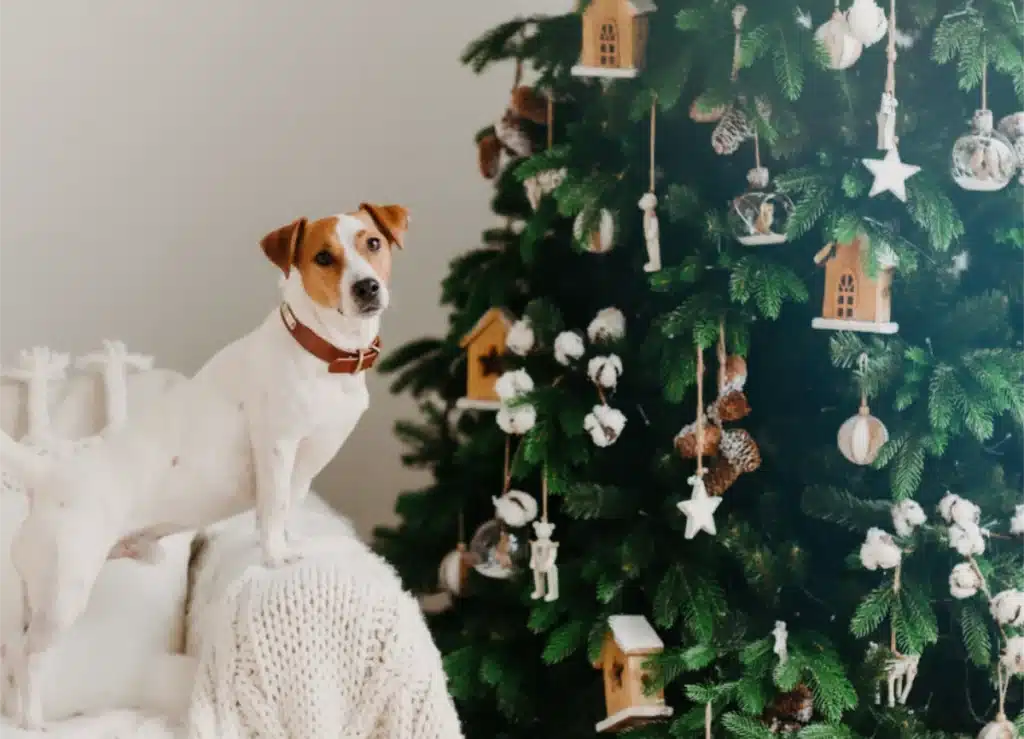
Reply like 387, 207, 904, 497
594, 615, 673, 732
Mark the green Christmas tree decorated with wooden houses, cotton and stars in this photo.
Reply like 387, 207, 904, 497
378, 0, 1024, 739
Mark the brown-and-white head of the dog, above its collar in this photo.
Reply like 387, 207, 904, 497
260, 203, 409, 318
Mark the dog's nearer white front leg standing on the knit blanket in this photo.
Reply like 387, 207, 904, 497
253, 439, 299, 567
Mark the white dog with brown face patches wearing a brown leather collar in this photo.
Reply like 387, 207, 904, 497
0, 204, 409, 728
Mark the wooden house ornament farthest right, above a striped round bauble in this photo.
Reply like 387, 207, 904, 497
811, 235, 899, 334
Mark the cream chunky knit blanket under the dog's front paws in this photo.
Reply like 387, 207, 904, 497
188, 515, 462, 739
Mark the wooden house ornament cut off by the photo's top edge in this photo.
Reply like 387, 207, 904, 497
572, 0, 657, 78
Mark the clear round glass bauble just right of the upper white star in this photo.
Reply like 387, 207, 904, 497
950, 110, 1020, 192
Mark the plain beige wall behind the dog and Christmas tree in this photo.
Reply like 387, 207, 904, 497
0, 0, 567, 532
